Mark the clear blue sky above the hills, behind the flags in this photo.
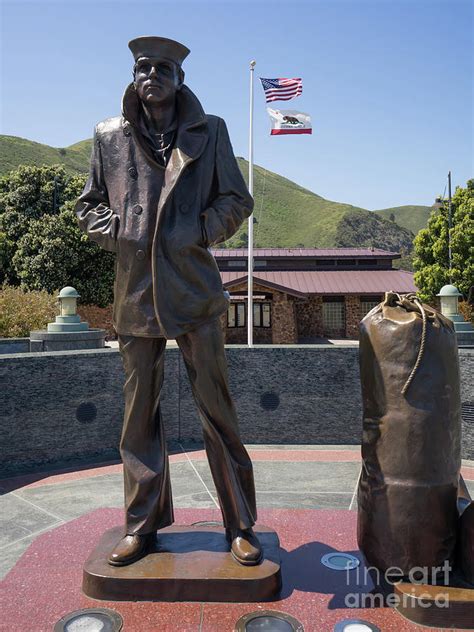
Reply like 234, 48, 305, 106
1, 0, 474, 209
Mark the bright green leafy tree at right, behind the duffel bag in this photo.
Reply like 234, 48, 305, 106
413, 180, 474, 302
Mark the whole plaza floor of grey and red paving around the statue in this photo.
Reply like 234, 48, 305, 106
0, 444, 474, 632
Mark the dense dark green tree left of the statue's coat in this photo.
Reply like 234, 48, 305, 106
0, 165, 114, 307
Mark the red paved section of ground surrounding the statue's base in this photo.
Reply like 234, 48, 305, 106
0, 509, 444, 632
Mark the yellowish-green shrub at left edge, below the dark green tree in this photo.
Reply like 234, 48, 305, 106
0, 285, 58, 338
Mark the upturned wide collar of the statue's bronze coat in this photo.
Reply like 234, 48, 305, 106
122, 83, 208, 166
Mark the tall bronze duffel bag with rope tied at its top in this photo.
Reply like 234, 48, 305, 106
357, 292, 461, 575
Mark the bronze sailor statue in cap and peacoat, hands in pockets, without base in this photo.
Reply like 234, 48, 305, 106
76, 37, 262, 566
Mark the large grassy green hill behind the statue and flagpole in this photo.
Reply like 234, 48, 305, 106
0, 136, 418, 265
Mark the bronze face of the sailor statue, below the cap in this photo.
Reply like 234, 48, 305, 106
135, 57, 182, 106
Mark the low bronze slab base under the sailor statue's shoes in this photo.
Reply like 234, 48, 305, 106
82, 524, 281, 602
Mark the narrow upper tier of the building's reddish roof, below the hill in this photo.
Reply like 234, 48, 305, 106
212, 248, 400, 259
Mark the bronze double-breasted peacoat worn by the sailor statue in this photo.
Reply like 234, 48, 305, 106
76, 84, 253, 338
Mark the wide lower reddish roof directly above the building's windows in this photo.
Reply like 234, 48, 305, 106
221, 270, 417, 296
